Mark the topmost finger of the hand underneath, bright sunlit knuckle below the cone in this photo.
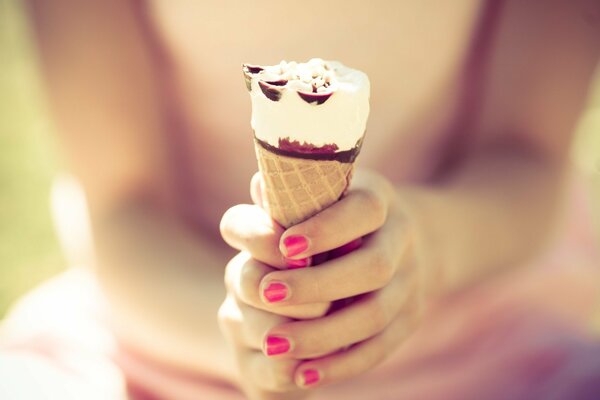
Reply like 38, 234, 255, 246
220, 204, 288, 268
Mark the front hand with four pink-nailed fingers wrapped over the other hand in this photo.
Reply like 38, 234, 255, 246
219, 168, 419, 394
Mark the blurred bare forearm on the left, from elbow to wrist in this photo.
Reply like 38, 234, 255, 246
93, 202, 235, 381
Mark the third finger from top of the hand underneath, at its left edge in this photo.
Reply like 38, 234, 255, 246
218, 295, 290, 350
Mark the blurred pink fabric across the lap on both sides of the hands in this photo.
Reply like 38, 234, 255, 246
0, 181, 600, 400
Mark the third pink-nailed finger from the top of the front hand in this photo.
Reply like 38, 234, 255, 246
264, 268, 416, 359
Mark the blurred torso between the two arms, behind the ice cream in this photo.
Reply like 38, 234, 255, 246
149, 0, 482, 232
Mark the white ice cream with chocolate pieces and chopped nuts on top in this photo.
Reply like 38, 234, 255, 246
247, 58, 370, 151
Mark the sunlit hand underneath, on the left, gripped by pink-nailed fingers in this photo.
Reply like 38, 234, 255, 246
219, 175, 330, 400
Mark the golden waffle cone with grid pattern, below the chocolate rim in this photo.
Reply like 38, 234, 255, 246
255, 143, 354, 228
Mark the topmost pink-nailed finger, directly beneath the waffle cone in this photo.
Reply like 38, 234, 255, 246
279, 171, 392, 258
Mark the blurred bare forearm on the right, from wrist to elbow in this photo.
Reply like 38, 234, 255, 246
399, 150, 564, 293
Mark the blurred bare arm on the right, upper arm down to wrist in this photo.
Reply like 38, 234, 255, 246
399, 0, 600, 291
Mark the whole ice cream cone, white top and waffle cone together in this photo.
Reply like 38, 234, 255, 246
243, 58, 370, 227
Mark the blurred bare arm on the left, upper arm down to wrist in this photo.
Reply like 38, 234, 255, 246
30, 0, 234, 378
